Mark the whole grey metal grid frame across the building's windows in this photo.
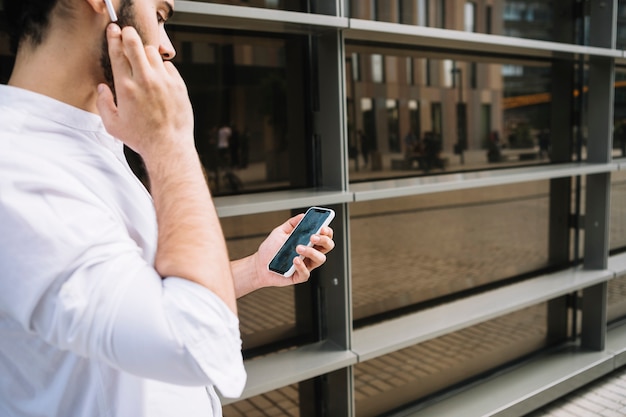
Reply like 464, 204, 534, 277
165, 0, 626, 416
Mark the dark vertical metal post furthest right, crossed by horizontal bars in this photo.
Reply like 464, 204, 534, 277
581, 0, 617, 350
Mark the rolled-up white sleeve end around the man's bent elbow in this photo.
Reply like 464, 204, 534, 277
110, 277, 246, 397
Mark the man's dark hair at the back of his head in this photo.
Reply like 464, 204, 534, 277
4, 0, 58, 52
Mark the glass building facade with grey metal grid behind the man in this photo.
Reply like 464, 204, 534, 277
0, 0, 626, 417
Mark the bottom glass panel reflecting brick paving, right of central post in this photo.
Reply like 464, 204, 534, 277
354, 304, 547, 417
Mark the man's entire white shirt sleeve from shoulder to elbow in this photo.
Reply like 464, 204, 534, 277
0, 154, 246, 397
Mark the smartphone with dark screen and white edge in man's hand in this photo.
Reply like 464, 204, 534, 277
268, 207, 335, 277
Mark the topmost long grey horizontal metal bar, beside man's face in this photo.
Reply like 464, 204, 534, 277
169, 5, 626, 63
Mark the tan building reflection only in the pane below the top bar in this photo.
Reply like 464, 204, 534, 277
346, 50, 503, 156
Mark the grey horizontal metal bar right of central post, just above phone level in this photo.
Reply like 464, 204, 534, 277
350, 163, 619, 201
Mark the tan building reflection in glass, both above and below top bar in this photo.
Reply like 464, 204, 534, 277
346, 1, 504, 158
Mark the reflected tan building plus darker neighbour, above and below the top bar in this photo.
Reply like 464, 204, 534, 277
346, 0, 554, 161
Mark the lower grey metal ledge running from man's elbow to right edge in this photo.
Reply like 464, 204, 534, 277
223, 255, 626, 404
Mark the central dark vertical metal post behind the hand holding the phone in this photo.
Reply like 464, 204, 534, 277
300, 13, 354, 417
